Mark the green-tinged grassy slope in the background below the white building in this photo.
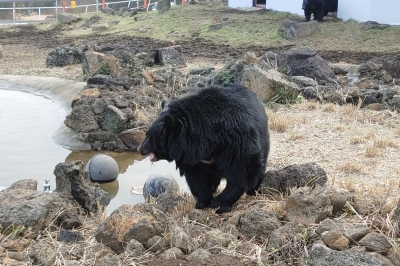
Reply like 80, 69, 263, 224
36, 4, 400, 53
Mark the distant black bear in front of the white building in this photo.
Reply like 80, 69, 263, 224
302, 0, 338, 22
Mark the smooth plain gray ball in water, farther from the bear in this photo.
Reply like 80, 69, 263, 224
86, 154, 119, 183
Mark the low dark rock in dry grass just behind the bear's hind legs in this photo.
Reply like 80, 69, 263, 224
259, 162, 328, 194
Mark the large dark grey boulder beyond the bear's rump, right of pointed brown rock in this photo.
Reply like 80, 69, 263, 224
277, 46, 335, 81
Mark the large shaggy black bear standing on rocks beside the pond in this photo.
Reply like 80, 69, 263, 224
138, 85, 270, 213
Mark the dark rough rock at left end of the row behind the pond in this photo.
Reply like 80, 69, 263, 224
46, 45, 84, 67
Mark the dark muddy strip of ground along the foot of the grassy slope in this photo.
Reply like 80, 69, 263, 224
0, 24, 394, 64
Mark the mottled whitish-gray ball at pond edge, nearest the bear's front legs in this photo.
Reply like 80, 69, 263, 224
143, 174, 179, 200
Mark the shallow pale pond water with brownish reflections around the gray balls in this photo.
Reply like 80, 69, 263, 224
0, 89, 188, 212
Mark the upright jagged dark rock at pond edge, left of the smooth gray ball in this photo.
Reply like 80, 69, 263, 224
54, 161, 111, 213
